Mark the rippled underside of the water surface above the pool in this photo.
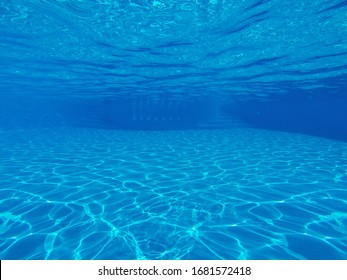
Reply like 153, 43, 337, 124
0, 0, 347, 99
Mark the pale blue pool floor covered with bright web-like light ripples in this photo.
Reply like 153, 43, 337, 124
0, 129, 347, 259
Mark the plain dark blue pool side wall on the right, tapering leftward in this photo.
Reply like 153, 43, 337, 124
224, 94, 347, 142
